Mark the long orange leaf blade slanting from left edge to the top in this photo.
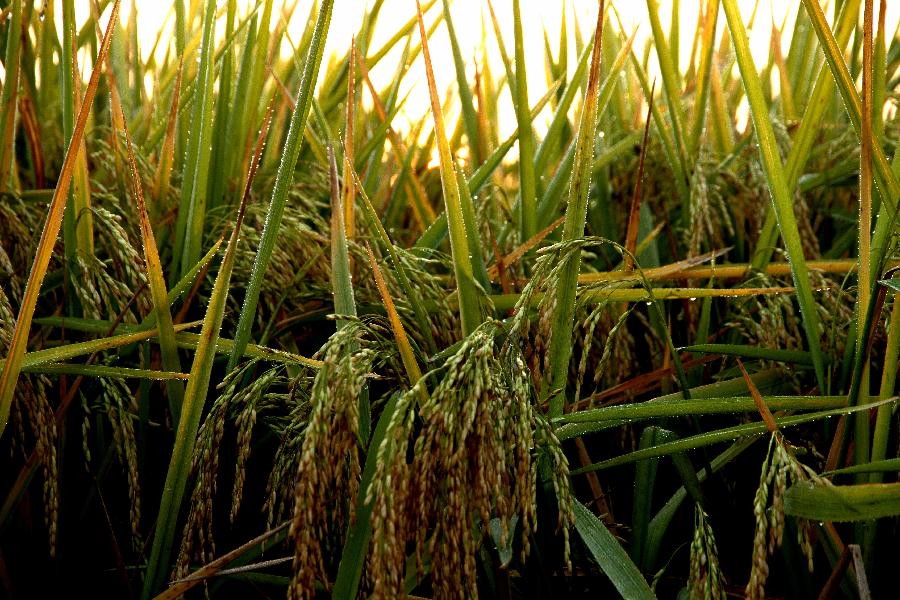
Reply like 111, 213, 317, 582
0, 0, 121, 436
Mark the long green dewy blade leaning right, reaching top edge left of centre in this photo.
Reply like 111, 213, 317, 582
228, 0, 334, 371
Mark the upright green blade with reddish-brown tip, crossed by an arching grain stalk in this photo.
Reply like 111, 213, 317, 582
541, 0, 605, 417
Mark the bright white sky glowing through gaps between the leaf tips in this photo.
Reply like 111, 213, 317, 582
84, 0, 900, 135
